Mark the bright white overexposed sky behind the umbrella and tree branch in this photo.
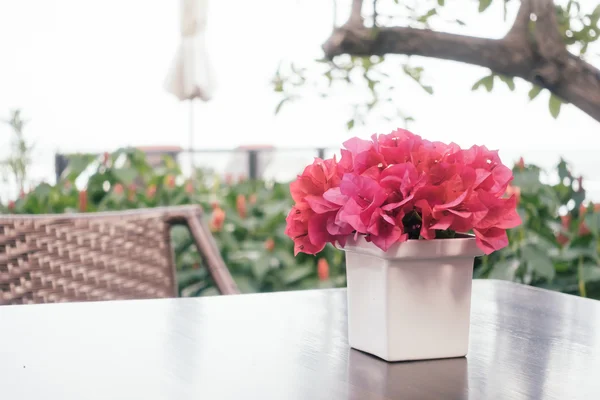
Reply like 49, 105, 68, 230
0, 0, 600, 197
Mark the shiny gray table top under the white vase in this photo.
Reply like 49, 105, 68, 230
0, 281, 600, 400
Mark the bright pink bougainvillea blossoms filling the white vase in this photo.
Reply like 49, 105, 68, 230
286, 129, 524, 254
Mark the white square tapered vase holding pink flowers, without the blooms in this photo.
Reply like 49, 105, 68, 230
344, 236, 482, 361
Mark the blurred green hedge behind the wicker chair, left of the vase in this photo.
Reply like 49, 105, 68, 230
2, 149, 346, 296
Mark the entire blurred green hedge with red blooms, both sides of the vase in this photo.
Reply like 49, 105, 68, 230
2, 149, 600, 298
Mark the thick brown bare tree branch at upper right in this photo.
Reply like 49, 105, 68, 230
323, 0, 600, 122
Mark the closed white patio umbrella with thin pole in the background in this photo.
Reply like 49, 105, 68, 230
165, 0, 215, 173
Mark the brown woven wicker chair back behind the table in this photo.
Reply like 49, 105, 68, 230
0, 206, 239, 305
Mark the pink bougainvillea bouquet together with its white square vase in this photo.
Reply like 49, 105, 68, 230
286, 129, 521, 361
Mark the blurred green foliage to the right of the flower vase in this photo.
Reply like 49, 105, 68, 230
475, 160, 600, 299
